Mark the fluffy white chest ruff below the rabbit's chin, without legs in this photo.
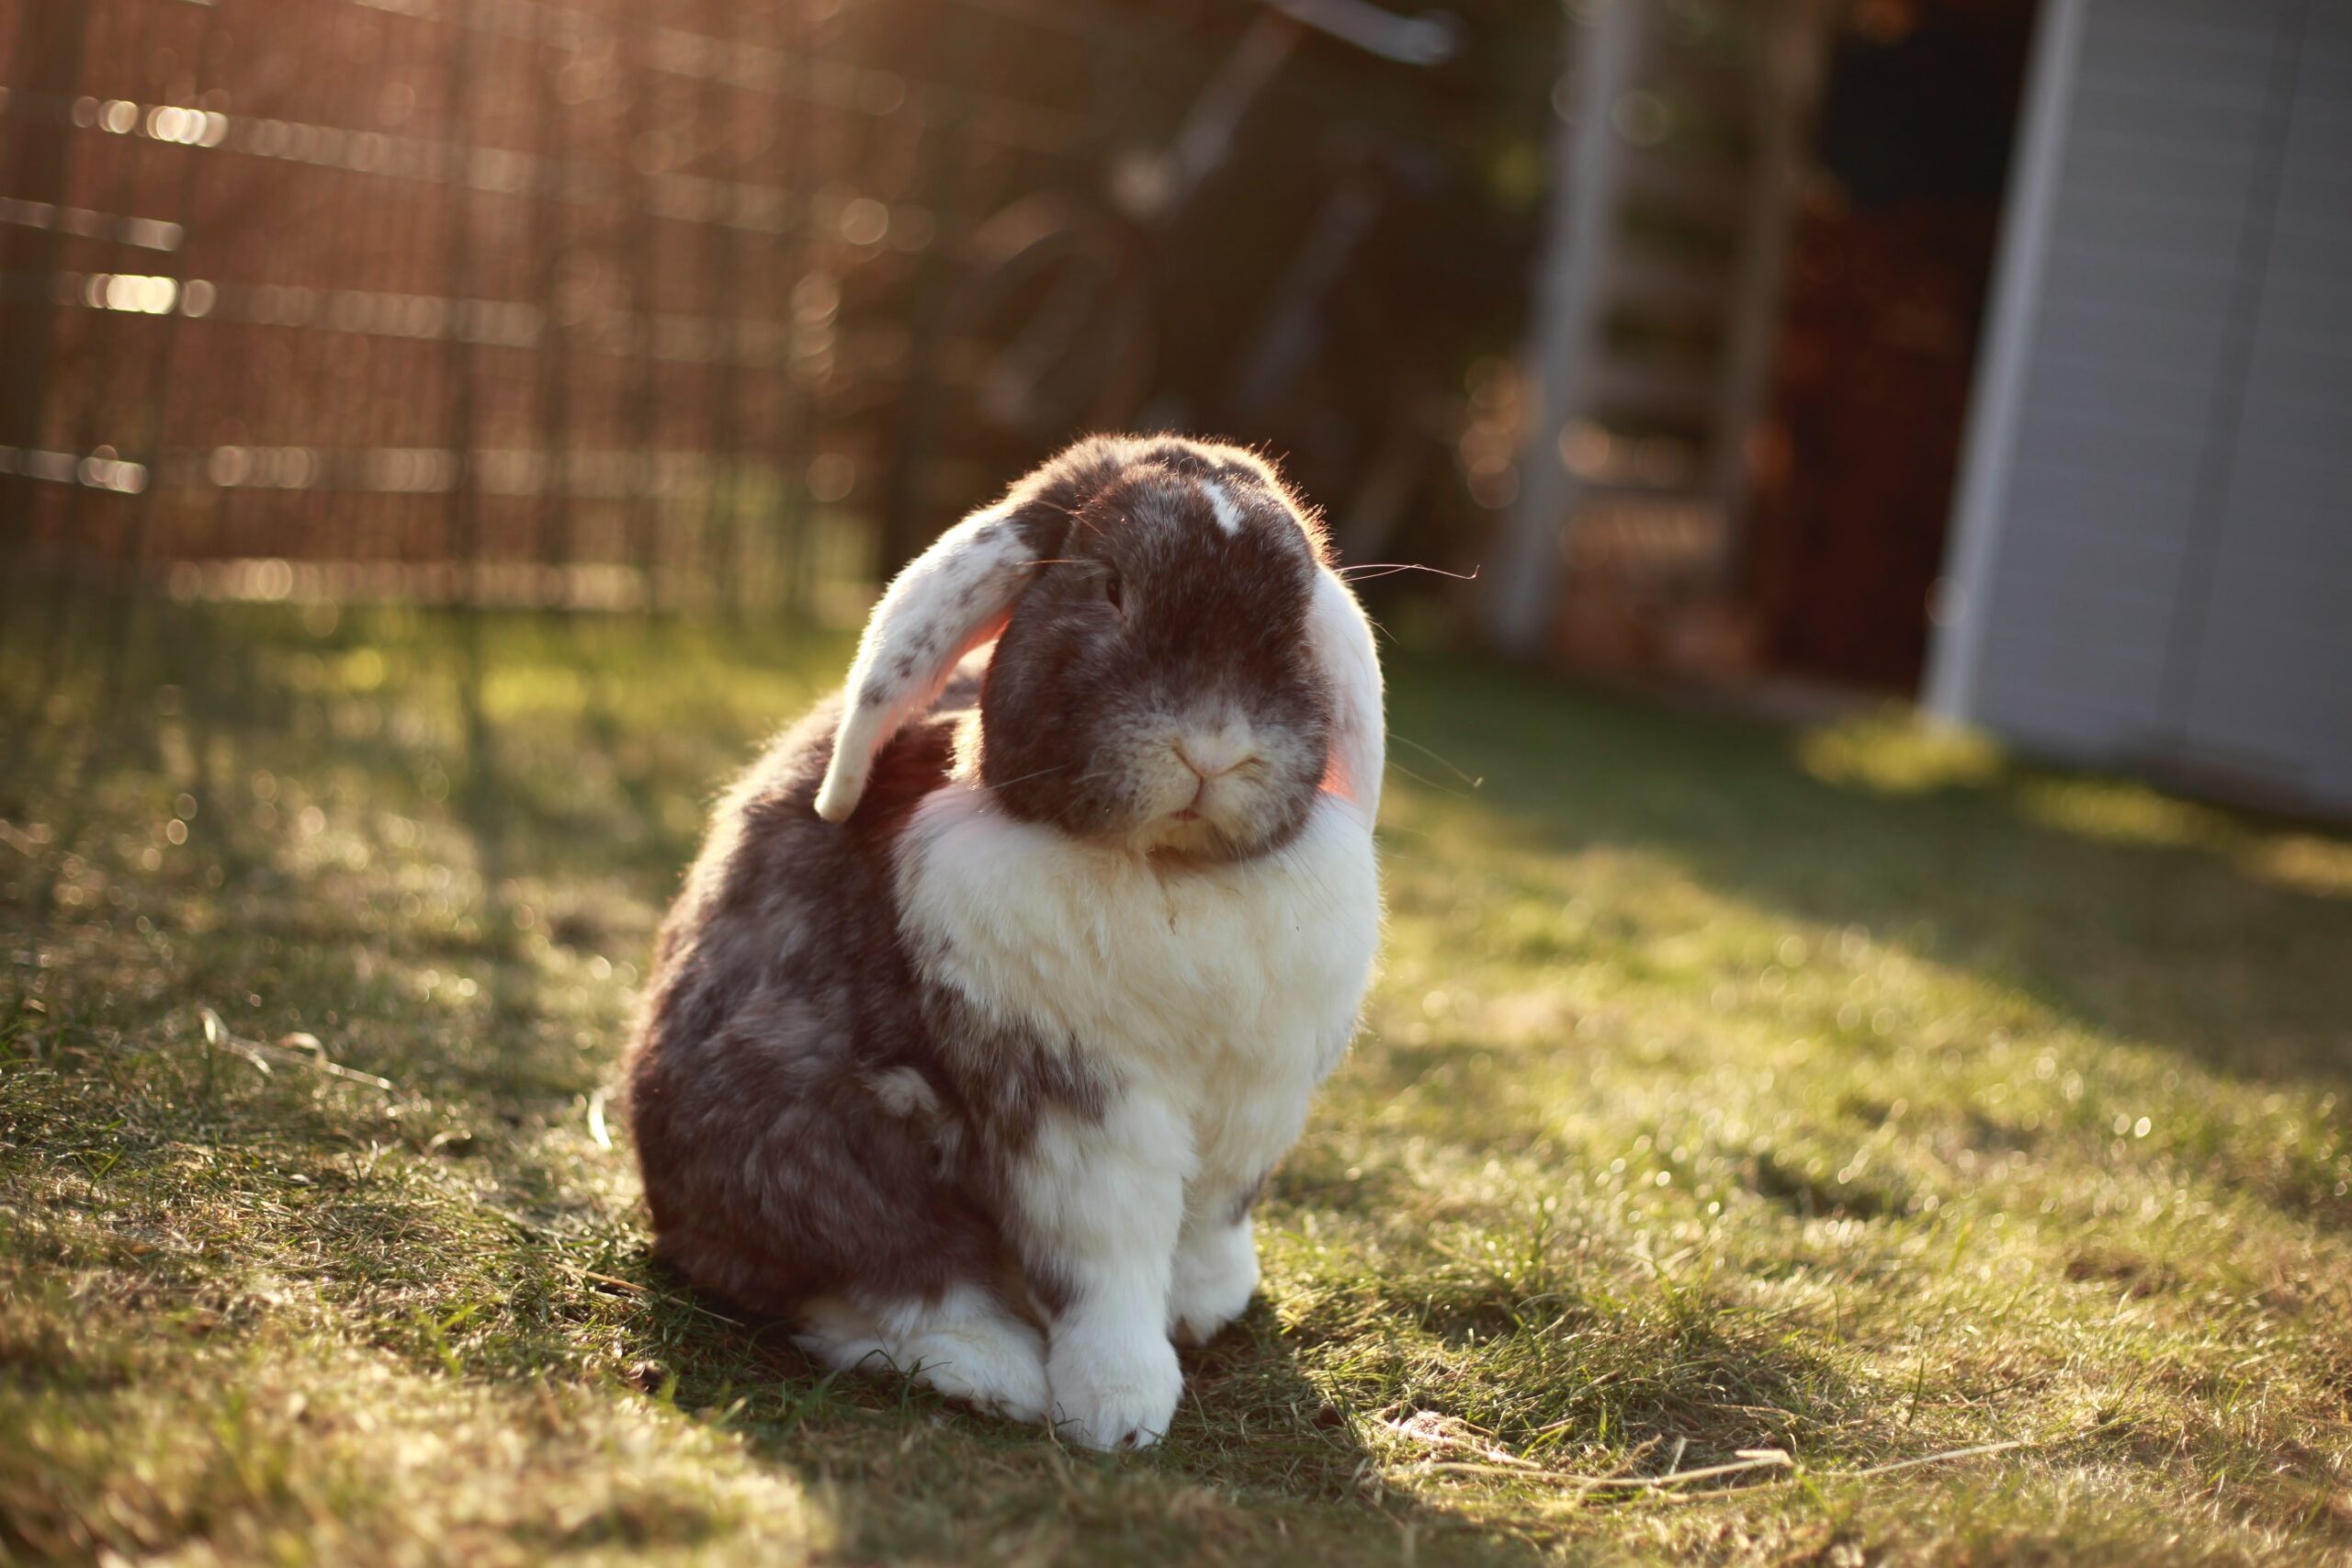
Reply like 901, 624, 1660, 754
899, 785, 1381, 1166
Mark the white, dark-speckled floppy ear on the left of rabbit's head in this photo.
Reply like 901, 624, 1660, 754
816, 505, 1037, 823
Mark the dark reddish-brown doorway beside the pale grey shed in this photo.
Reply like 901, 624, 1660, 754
1746, 0, 2034, 694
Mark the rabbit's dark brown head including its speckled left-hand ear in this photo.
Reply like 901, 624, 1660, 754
819, 437, 1336, 861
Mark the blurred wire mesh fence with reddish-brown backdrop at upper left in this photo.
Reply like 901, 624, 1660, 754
0, 0, 1194, 625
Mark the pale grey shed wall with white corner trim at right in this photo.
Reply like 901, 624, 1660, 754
1936, 0, 2352, 807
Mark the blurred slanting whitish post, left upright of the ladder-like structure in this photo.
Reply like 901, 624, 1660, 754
1484, 0, 1651, 656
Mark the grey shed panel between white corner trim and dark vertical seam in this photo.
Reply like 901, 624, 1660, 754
1975, 0, 2275, 750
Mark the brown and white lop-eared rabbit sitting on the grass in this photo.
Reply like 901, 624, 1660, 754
626, 437, 1385, 1448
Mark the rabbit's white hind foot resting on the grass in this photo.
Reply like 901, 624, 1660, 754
793, 1286, 1049, 1422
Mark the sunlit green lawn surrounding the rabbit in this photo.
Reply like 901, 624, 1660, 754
0, 594, 2352, 1563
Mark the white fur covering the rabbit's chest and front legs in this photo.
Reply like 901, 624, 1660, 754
899, 751, 1381, 1446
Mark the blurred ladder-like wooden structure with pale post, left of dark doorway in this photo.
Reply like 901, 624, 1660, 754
1482, 0, 1830, 656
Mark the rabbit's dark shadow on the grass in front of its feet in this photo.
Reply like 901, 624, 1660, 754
638, 1260, 1536, 1561
